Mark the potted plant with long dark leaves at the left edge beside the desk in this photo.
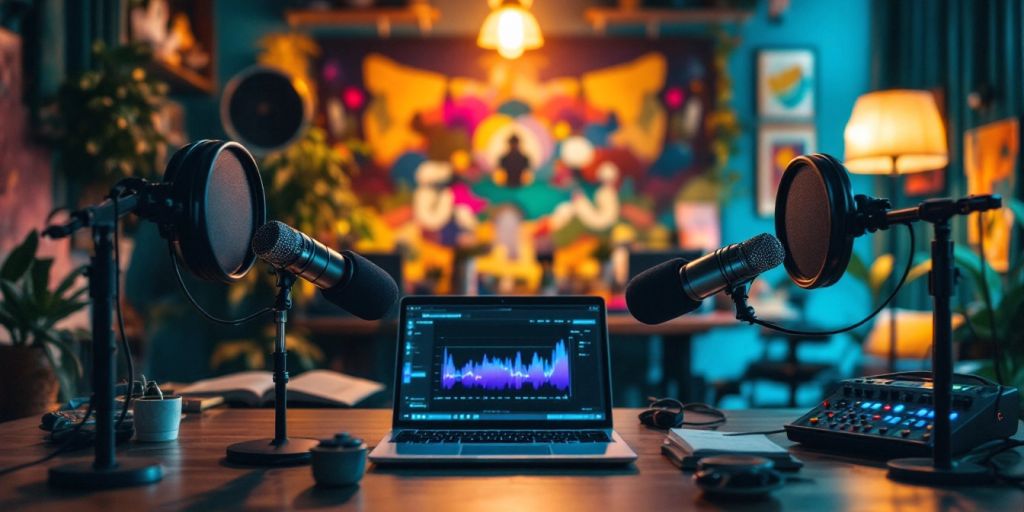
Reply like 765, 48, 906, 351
0, 231, 88, 421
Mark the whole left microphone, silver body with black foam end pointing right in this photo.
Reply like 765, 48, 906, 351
253, 220, 398, 319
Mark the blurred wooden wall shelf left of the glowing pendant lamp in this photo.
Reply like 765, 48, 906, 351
285, 3, 440, 37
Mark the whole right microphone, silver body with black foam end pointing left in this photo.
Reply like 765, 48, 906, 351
626, 232, 785, 325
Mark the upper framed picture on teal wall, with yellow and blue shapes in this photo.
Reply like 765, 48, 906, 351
757, 49, 817, 120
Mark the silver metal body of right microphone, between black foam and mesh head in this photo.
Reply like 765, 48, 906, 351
679, 244, 761, 300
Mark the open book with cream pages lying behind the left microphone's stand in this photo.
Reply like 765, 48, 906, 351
178, 370, 384, 407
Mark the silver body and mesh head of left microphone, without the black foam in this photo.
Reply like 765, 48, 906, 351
253, 221, 349, 290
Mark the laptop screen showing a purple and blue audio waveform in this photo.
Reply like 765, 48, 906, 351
394, 297, 611, 428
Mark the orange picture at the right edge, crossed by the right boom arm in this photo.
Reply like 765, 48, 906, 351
964, 118, 1020, 272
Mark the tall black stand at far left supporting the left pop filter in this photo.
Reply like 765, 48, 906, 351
43, 190, 163, 488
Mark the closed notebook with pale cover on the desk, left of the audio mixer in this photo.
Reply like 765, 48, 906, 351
662, 428, 804, 470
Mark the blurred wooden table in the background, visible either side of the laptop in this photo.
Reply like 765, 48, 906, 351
299, 311, 740, 336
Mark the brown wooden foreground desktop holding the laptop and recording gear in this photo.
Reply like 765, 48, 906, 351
0, 409, 1024, 512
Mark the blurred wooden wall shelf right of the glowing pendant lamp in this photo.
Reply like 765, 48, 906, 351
584, 7, 753, 36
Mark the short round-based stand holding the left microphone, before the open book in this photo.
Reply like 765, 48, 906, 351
227, 269, 318, 466
